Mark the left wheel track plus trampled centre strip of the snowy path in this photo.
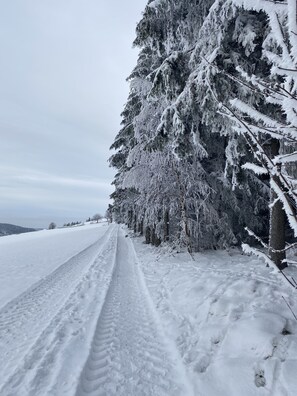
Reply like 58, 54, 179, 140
0, 225, 118, 396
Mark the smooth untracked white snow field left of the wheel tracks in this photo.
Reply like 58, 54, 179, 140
0, 224, 106, 307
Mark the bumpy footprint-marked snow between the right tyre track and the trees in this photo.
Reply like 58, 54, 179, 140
134, 239, 297, 396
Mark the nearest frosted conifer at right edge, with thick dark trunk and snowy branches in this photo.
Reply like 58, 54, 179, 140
198, 0, 297, 269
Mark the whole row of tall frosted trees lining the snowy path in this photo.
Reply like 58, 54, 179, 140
109, 0, 297, 269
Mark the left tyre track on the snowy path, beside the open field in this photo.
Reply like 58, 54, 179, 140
0, 226, 116, 395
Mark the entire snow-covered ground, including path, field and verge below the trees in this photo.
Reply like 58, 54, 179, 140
0, 224, 297, 396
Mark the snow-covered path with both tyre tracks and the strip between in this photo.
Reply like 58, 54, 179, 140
0, 225, 191, 396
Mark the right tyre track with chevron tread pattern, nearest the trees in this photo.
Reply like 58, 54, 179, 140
76, 232, 192, 396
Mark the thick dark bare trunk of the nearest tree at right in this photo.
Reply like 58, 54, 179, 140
269, 139, 287, 270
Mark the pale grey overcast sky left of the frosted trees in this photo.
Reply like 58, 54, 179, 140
0, 0, 147, 227
